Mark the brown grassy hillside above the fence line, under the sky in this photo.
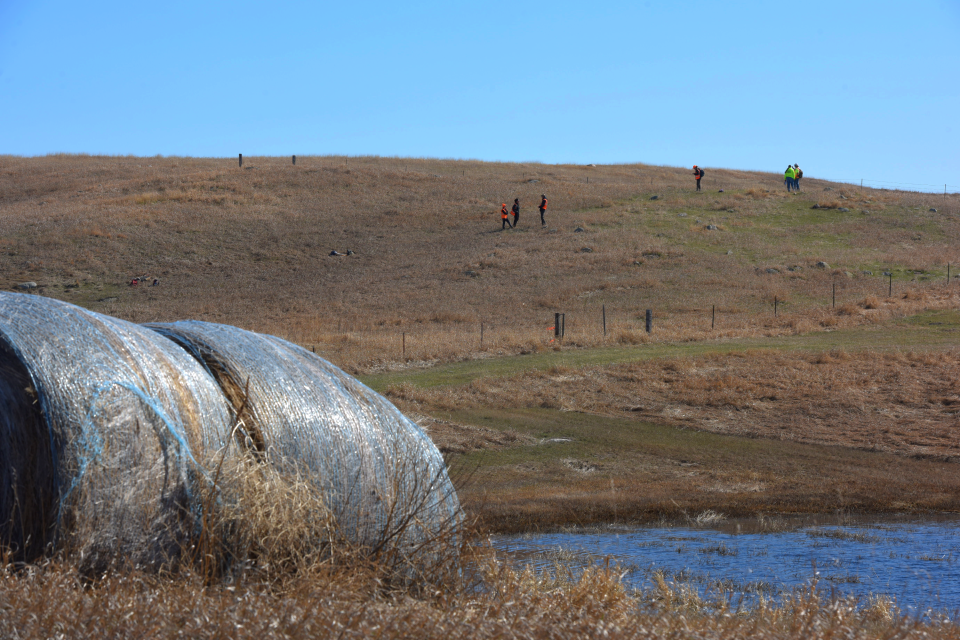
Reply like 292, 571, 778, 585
0, 155, 960, 372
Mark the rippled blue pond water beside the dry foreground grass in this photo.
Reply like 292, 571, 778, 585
494, 519, 960, 614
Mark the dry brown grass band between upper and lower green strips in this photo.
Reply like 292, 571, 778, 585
387, 349, 960, 461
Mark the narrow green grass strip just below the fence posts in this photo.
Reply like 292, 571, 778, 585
360, 311, 960, 391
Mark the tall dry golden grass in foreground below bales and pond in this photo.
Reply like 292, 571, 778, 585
0, 552, 960, 640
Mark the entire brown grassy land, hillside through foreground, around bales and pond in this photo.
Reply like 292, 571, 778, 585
0, 155, 960, 638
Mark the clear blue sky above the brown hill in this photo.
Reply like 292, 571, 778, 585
0, 0, 960, 191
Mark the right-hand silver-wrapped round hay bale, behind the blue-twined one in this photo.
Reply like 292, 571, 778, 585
147, 321, 461, 554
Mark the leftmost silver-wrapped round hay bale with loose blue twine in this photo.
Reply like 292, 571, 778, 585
0, 293, 232, 567
